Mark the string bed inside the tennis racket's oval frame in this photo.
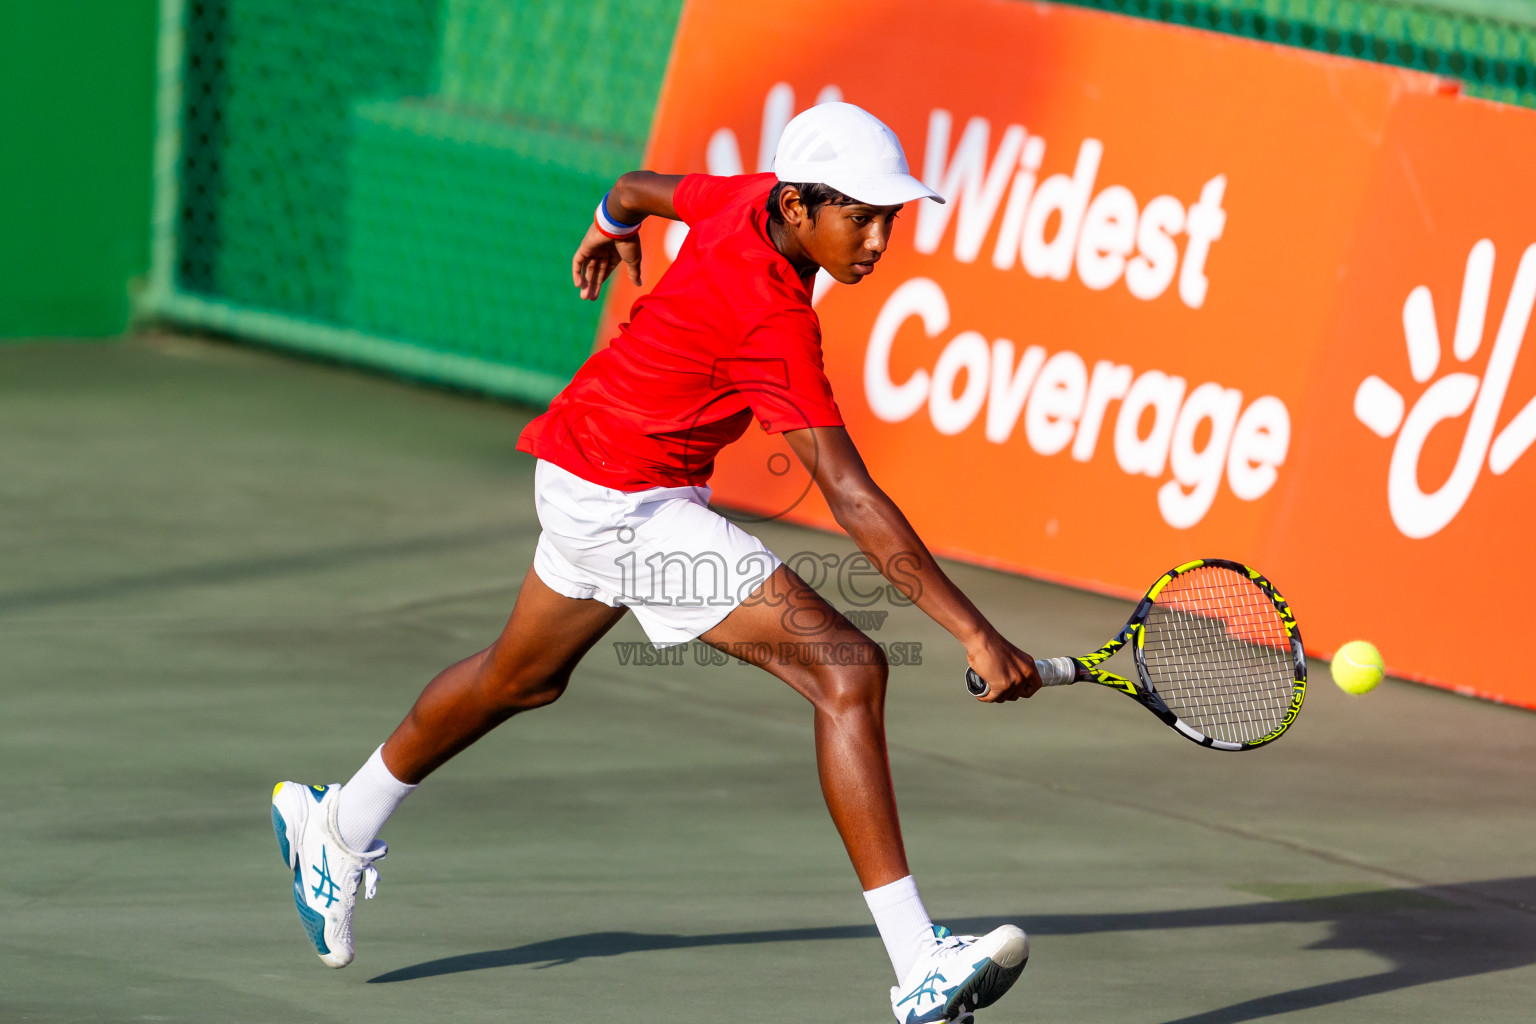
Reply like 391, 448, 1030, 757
1141, 565, 1296, 743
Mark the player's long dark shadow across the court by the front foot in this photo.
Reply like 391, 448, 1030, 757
369, 877, 1536, 1024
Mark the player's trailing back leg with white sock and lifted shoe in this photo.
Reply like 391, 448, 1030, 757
272, 568, 624, 967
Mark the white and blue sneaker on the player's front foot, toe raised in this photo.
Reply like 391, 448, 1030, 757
891, 924, 1029, 1024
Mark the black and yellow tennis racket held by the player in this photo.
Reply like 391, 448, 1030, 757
965, 559, 1307, 751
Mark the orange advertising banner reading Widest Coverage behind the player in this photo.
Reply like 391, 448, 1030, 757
602, 0, 1536, 706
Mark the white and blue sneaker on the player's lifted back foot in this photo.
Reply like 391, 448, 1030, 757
272, 781, 389, 967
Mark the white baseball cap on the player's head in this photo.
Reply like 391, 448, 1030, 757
773, 103, 945, 206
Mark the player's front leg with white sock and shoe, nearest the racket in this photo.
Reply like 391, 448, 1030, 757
700, 565, 1029, 1024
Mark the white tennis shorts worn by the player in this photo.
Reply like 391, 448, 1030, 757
533, 459, 780, 646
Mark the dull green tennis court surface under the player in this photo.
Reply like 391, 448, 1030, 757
0, 338, 1536, 1024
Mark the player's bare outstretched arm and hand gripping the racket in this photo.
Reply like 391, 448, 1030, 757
783, 427, 1040, 703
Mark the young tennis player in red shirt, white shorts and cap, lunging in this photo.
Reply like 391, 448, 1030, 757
272, 103, 1040, 1024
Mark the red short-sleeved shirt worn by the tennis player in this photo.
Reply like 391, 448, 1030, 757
518, 173, 843, 491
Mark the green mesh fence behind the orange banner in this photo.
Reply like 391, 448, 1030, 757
146, 0, 1536, 401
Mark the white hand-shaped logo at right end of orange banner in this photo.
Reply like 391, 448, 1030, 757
1355, 238, 1536, 539
